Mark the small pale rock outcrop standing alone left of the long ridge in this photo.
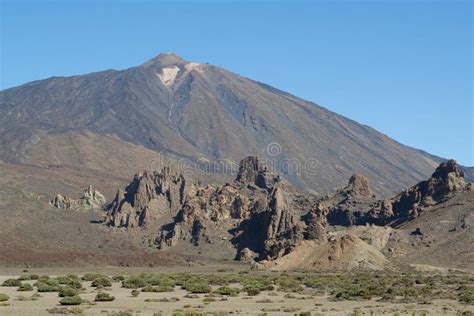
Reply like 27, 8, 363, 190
50, 185, 106, 210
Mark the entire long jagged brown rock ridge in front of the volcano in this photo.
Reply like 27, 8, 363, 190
105, 157, 471, 268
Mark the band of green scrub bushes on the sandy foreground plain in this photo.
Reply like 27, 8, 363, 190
0, 271, 474, 315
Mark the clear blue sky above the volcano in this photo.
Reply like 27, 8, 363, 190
0, 0, 474, 166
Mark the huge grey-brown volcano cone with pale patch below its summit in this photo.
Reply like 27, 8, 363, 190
0, 54, 462, 195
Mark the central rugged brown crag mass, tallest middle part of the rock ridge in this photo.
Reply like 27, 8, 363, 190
155, 157, 325, 260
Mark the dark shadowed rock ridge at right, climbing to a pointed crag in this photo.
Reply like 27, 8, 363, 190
316, 160, 472, 226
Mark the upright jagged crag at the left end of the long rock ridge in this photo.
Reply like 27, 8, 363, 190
105, 167, 187, 228
